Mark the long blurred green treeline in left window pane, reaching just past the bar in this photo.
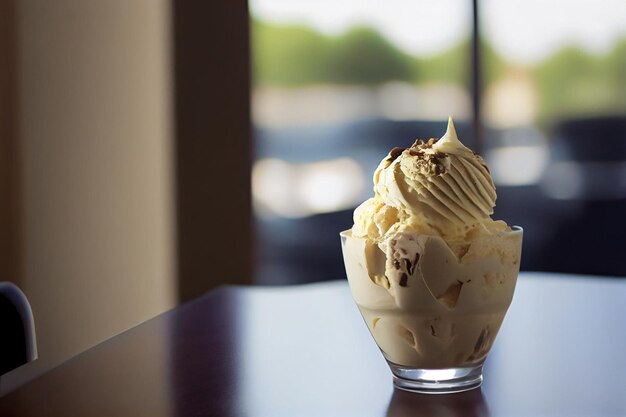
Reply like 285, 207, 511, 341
252, 19, 528, 93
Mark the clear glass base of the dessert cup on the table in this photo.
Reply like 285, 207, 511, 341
387, 362, 483, 394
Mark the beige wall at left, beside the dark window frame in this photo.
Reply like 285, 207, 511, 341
18, 0, 176, 366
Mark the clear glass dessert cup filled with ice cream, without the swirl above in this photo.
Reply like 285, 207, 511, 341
340, 227, 523, 394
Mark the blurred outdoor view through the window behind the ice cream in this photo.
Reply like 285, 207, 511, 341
251, 0, 626, 284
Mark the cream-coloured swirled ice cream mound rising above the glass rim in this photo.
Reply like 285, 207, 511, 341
353, 118, 502, 240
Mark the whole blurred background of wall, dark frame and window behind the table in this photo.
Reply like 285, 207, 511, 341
0, 0, 626, 391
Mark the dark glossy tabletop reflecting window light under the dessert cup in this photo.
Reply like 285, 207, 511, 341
0, 273, 626, 417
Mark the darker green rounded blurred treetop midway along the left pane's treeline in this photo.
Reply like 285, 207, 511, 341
328, 26, 415, 85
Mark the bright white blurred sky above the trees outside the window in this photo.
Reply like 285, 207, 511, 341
250, 0, 626, 63
